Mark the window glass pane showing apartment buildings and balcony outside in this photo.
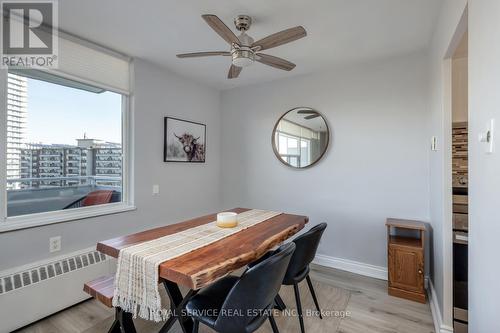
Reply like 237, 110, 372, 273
6, 71, 123, 216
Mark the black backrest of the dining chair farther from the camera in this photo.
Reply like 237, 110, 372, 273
285, 223, 327, 280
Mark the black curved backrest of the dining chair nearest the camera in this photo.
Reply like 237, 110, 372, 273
215, 243, 295, 332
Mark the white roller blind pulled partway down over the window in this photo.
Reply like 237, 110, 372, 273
50, 34, 130, 94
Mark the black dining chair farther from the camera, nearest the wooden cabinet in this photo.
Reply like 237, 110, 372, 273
249, 223, 327, 333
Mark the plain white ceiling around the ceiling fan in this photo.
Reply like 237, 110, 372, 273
59, 0, 441, 89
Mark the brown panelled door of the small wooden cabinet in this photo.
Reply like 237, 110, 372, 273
389, 246, 424, 292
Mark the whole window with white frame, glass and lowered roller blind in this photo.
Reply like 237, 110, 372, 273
0, 32, 134, 232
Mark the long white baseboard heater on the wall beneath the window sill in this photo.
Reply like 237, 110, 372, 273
0, 248, 116, 333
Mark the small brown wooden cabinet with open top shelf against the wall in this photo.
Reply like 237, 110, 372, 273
386, 219, 426, 303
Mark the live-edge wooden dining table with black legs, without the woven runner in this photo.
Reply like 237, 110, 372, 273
97, 208, 309, 333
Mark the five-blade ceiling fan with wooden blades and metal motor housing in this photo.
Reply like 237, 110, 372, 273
177, 14, 307, 79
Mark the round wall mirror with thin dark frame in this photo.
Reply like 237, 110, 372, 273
272, 107, 330, 168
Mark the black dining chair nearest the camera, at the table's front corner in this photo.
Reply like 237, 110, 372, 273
186, 243, 295, 333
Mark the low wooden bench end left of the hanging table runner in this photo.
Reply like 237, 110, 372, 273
83, 275, 136, 333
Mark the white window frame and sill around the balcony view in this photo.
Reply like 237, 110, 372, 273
0, 66, 136, 233
